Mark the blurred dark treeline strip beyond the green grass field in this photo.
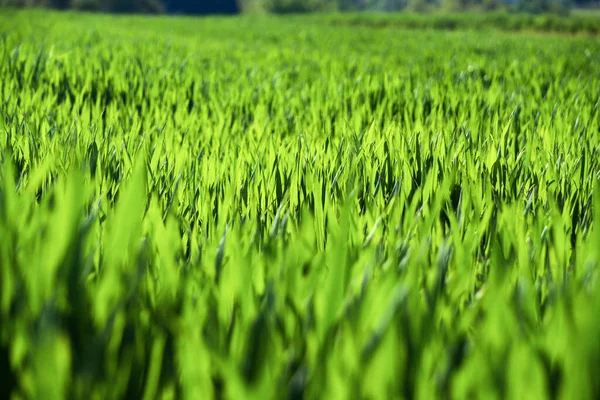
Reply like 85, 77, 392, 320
0, 0, 598, 14
